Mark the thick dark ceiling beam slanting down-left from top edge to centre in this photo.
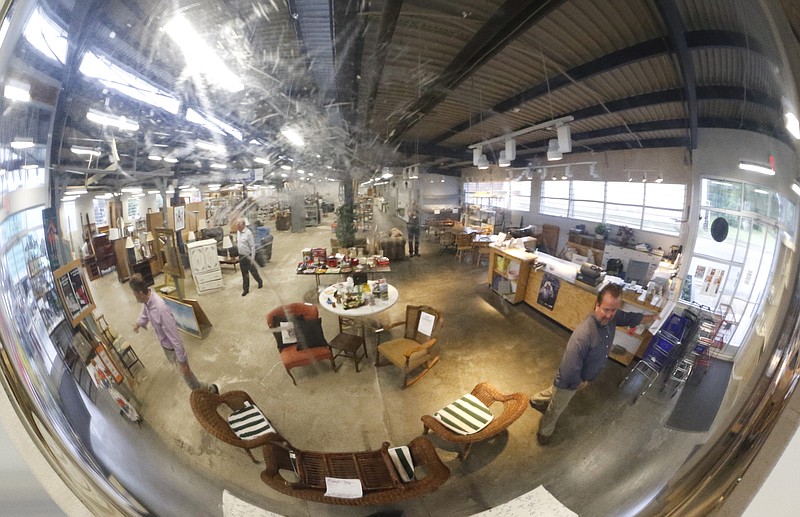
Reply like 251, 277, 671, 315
389, 0, 564, 142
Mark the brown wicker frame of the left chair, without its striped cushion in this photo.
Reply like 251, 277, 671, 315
190, 390, 283, 463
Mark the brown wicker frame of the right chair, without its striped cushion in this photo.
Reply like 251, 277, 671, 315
422, 382, 528, 460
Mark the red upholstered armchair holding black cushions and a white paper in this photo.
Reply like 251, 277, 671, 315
267, 303, 336, 386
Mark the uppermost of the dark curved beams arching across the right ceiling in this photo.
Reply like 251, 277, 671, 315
432, 30, 763, 144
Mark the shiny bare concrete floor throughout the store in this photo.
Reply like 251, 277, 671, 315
83, 213, 735, 517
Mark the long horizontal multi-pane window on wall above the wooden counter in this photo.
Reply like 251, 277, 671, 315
539, 177, 686, 235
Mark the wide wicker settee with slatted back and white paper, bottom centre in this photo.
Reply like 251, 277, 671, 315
261, 436, 450, 506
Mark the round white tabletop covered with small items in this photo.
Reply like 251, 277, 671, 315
319, 280, 400, 317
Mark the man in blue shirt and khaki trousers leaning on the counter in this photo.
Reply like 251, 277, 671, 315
530, 284, 656, 445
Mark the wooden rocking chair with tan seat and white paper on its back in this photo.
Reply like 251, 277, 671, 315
375, 305, 443, 388
